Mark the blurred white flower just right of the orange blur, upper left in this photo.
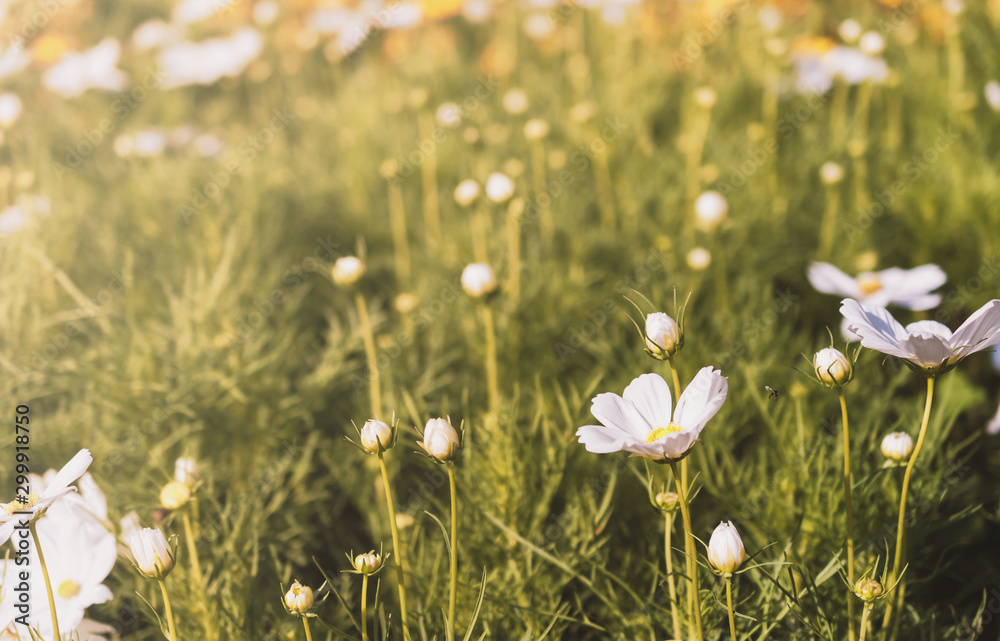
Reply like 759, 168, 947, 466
42, 38, 128, 98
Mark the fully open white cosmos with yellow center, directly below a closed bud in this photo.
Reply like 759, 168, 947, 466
576, 367, 729, 461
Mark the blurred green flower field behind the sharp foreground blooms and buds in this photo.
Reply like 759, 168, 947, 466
0, 0, 1000, 641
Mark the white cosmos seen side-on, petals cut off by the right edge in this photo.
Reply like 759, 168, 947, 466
840, 298, 1000, 376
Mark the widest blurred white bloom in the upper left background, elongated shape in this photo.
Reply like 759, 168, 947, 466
158, 28, 263, 89
